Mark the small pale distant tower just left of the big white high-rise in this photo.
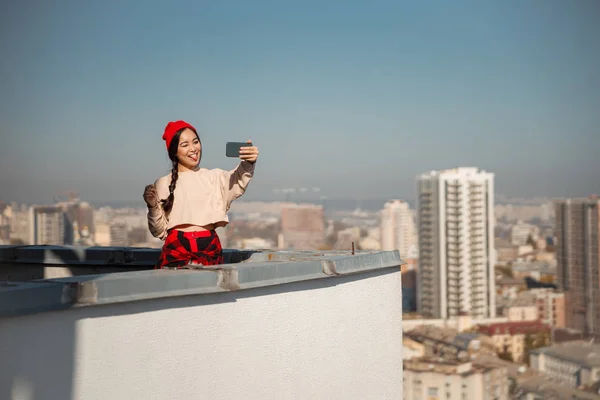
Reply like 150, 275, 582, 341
380, 200, 415, 258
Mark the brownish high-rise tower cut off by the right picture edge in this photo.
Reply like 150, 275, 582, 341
555, 196, 600, 339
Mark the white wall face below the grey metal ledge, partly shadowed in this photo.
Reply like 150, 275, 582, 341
0, 270, 403, 400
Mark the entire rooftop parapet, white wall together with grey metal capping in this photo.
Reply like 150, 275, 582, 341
0, 246, 403, 400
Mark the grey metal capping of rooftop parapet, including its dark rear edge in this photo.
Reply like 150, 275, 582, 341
0, 246, 403, 317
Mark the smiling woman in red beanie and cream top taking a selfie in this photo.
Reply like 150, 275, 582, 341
144, 121, 258, 269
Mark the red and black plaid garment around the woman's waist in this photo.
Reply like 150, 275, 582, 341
154, 229, 223, 269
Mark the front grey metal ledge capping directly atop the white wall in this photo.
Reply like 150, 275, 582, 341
0, 247, 403, 317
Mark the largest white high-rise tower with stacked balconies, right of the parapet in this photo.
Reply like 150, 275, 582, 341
417, 168, 496, 318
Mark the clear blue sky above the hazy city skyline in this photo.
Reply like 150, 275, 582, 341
0, 0, 600, 202
